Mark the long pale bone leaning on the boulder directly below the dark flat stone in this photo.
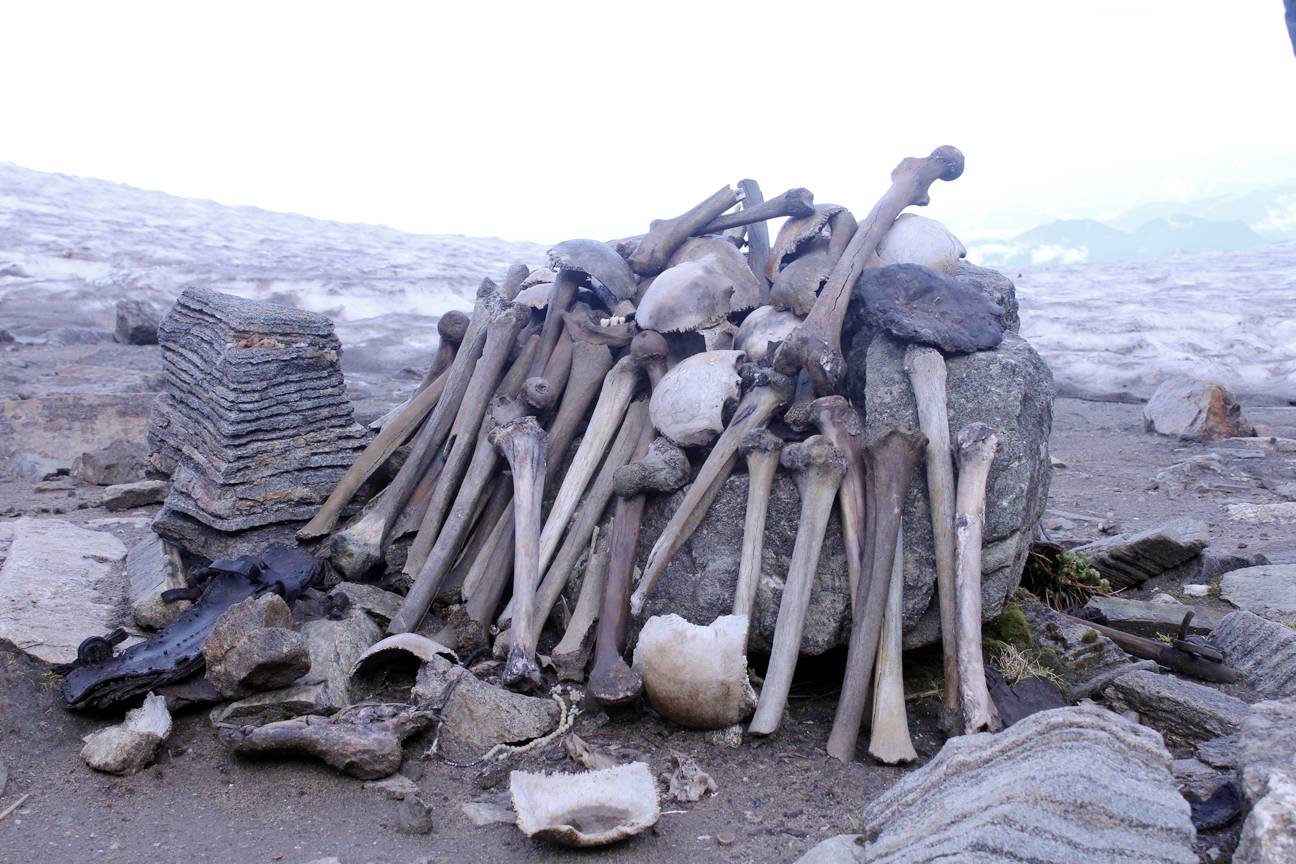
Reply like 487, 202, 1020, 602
905, 345, 960, 732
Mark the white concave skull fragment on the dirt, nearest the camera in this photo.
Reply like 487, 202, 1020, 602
508, 762, 661, 847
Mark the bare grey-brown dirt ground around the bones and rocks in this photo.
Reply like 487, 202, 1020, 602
0, 327, 1296, 864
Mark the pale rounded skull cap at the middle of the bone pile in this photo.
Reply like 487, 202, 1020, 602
648, 351, 744, 447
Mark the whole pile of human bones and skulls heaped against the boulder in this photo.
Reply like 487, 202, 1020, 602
298, 146, 1003, 762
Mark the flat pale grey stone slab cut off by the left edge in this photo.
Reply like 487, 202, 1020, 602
0, 518, 128, 665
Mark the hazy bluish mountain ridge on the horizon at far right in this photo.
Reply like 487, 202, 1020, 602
968, 183, 1296, 267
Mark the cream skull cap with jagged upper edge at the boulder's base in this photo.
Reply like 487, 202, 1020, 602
634, 614, 756, 729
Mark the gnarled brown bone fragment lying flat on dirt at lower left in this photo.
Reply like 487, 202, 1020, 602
220, 702, 435, 780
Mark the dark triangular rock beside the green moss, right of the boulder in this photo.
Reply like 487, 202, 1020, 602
1021, 596, 1156, 702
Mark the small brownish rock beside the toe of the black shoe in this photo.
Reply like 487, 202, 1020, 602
202, 595, 311, 698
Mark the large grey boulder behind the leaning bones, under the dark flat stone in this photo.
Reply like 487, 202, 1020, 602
636, 264, 1054, 655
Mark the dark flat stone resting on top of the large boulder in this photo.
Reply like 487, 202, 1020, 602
848, 264, 1007, 354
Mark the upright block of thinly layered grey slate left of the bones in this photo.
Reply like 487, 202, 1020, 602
149, 288, 367, 531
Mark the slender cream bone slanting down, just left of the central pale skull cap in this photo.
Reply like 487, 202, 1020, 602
539, 355, 639, 580
